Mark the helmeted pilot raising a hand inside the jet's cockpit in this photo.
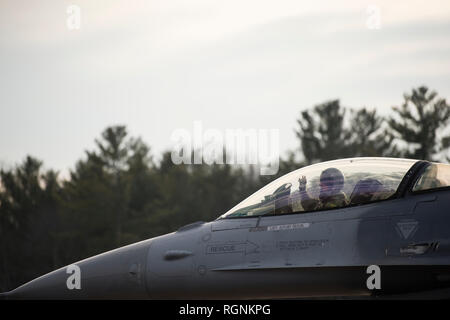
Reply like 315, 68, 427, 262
298, 168, 349, 211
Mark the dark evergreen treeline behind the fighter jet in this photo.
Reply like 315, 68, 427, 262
0, 87, 450, 292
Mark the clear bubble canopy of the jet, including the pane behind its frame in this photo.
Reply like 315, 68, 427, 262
220, 158, 450, 218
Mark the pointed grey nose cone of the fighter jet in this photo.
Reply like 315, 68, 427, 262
1, 239, 152, 299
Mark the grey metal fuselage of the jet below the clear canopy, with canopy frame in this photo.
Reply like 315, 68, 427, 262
3, 159, 450, 299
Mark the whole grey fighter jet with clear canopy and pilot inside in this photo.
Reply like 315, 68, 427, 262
2, 158, 450, 299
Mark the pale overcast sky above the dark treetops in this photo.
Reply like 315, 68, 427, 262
0, 0, 450, 175
